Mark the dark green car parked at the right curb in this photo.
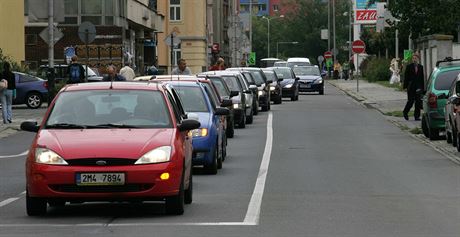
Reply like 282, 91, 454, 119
422, 58, 460, 140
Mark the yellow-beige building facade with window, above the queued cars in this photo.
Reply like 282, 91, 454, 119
158, 0, 209, 74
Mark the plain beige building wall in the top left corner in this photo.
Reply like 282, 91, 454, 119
0, 0, 25, 64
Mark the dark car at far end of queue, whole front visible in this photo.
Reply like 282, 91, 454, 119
292, 66, 324, 95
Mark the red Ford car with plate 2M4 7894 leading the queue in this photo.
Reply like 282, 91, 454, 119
21, 82, 200, 216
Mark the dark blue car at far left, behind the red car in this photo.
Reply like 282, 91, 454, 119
13, 72, 48, 109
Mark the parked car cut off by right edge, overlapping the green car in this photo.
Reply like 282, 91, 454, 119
444, 74, 460, 151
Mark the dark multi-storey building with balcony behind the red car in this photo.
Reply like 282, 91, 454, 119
25, 0, 165, 74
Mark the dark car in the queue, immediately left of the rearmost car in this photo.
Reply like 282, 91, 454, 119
272, 67, 299, 101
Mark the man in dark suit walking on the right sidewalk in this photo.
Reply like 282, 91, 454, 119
403, 53, 425, 120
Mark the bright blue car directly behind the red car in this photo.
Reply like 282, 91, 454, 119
167, 81, 229, 174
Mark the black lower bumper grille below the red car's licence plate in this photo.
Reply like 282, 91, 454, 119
49, 184, 153, 193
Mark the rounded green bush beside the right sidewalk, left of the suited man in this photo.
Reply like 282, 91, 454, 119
361, 57, 391, 82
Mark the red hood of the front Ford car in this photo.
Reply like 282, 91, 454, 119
37, 128, 175, 159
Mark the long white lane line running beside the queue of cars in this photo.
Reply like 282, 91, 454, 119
243, 112, 273, 225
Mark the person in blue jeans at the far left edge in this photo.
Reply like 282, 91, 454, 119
0, 62, 16, 124
